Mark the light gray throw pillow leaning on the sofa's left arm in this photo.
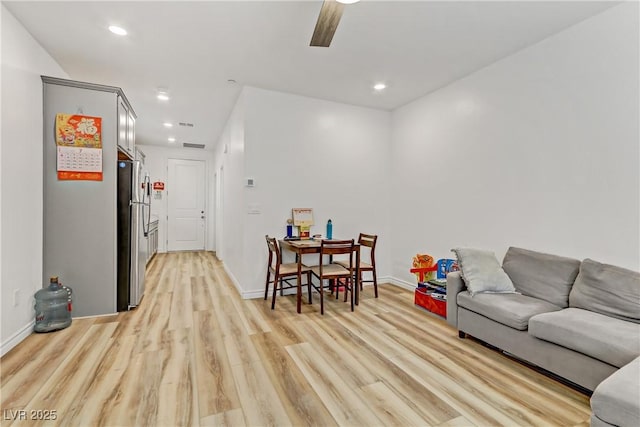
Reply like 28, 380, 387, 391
451, 248, 516, 296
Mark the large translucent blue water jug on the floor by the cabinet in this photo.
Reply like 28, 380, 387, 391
33, 276, 72, 332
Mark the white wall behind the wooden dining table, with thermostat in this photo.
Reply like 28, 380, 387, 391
230, 87, 390, 296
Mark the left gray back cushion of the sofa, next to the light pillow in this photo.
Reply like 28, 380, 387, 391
502, 247, 580, 308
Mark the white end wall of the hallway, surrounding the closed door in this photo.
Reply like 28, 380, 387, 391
137, 145, 215, 252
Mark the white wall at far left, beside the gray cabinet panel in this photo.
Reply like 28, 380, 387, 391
0, 6, 68, 354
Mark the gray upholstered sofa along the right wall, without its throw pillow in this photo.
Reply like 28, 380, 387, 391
447, 247, 640, 425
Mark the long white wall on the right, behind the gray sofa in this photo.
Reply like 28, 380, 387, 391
390, 2, 640, 283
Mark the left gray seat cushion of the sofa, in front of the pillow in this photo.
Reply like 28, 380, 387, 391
457, 291, 560, 331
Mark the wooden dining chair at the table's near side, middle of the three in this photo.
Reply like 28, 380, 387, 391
311, 239, 355, 314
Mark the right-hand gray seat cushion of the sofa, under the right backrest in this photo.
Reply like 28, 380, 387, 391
529, 308, 640, 368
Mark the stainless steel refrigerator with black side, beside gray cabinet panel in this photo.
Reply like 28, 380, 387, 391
117, 152, 151, 311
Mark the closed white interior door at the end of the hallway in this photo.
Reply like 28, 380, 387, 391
167, 159, 207, 251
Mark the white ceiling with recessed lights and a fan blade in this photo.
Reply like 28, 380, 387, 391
2, 0, 616, 148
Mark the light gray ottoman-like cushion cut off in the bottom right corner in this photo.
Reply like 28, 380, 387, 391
591, 357, 640, 426
